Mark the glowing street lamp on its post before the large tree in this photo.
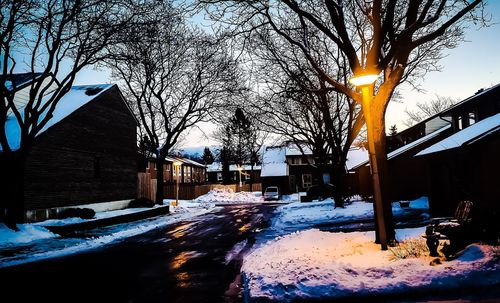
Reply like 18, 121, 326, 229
349, 73, 388, 250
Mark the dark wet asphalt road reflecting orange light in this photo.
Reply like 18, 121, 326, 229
0, 205, 275, 302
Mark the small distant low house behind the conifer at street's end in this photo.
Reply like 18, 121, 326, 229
207, 162, 261, 184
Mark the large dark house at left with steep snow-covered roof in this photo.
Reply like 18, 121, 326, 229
0, 84, 137, 221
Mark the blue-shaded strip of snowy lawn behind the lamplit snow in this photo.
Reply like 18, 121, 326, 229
273, 197, 429, 229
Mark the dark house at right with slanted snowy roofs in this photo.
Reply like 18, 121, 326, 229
353, 84, 500, 220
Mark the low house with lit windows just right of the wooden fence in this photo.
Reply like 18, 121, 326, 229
144, 157, 206, 185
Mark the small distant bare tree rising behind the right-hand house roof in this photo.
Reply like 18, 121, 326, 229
403, 95, 460, 127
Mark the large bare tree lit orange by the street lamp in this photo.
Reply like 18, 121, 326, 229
200, 0, 485, 249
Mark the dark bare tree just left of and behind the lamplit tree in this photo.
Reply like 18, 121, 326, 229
251, 28, 364, 207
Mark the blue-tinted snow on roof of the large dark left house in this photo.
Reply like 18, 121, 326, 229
0, 84, 113, 150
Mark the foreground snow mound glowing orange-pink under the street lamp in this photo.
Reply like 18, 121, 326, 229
242, 229, 500, 302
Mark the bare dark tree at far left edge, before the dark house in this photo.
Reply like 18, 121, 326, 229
0, 0, 137, 229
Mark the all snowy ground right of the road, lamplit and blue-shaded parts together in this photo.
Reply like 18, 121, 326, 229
241, 197, 500, 302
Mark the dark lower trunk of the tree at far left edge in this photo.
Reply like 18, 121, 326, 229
0, 151, 26, 231
